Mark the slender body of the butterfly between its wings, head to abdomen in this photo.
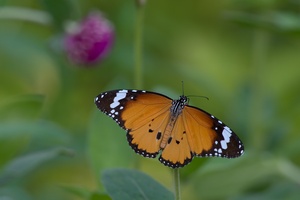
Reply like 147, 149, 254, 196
160, 96, 188, 149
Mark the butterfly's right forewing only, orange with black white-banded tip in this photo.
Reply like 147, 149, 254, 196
183, 106, 244, 158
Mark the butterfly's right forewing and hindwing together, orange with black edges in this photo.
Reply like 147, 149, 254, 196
159, 105, 244, 168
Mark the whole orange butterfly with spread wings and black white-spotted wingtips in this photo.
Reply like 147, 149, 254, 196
95, 89, 244, 168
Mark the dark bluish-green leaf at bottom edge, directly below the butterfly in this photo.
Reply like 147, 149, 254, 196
101, 169, 174, 200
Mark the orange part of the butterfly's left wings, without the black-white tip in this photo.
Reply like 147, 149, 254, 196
121, 93, 172, 158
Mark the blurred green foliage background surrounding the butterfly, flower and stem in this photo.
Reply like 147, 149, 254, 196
0, 0, 300, 200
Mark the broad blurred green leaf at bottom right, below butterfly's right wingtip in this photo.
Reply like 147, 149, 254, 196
189, 154, 300, 199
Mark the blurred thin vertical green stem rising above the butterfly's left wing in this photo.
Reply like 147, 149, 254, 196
134, 2, 145, 89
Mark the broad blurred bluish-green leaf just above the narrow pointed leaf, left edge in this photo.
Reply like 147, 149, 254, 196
0, 120, 70, 165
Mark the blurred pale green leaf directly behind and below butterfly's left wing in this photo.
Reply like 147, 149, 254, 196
88, 110, 135, 177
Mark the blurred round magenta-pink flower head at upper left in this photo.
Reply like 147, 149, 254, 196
64, 12, 114, 64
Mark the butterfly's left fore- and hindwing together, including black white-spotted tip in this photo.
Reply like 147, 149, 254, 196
95, 90, 172, 158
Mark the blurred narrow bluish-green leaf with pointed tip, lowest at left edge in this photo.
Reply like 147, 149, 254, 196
0, 148, 73, 184
